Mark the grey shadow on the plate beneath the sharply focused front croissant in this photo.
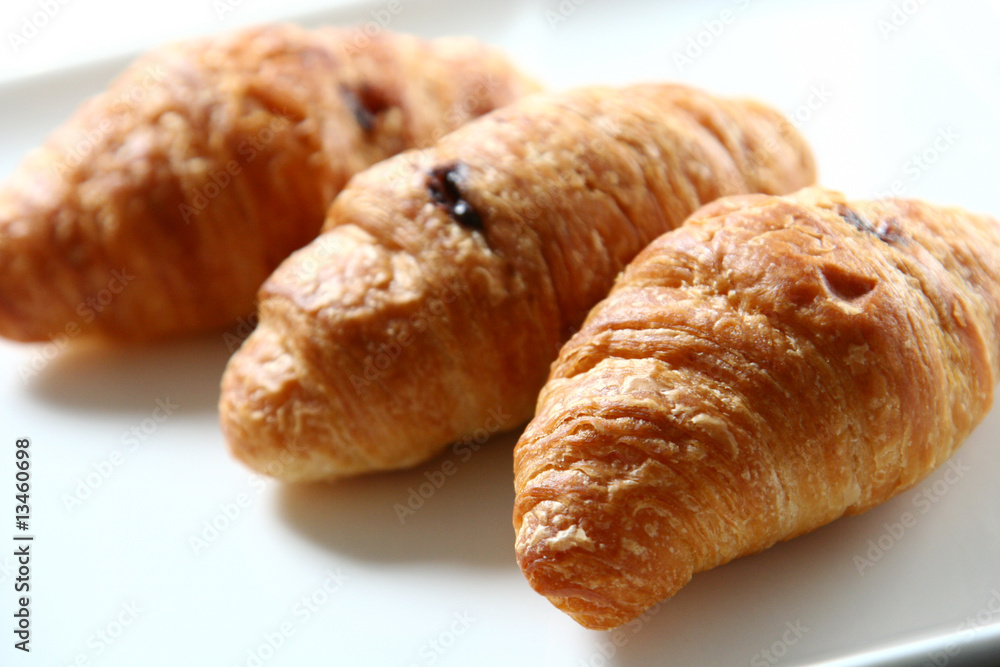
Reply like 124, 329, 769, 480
584, 464, 988, 667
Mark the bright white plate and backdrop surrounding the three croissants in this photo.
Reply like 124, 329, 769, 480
0, 0, 1000, 666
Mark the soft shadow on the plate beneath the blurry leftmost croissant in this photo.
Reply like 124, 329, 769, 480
27, 333, 231, 414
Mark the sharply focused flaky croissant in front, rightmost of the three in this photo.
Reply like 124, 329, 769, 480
514, 188, 1000, 629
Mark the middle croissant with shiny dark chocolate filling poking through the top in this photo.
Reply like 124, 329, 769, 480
220, 84, 814, 481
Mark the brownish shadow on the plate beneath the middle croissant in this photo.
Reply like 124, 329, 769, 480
279, 433, 518, 568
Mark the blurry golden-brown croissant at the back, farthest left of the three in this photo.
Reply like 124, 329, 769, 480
0, 25, 537, 341
